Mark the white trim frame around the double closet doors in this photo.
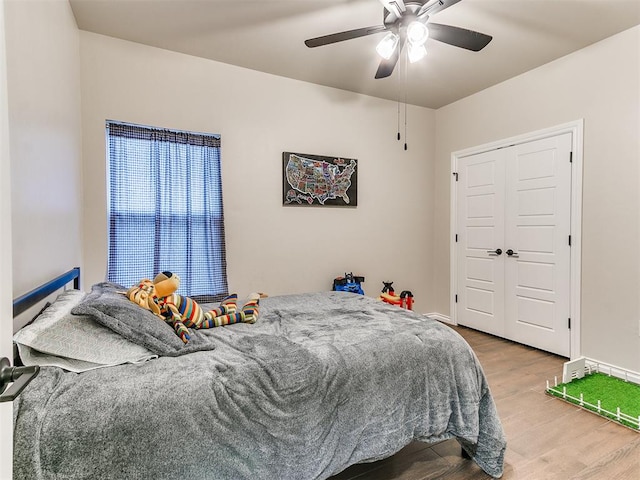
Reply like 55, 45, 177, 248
449, 119, 584, 359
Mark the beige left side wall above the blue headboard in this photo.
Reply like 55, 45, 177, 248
5, 0, 82, 329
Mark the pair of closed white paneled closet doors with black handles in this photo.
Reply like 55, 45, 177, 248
456, 133, 571, 357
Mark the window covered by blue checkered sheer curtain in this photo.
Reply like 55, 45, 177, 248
107, 121, 228, 301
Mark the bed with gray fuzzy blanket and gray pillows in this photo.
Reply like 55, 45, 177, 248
14, 268, 506, 480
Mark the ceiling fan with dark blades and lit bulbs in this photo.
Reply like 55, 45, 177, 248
304, 0, 493, 78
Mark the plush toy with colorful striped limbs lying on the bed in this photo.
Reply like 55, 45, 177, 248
127, 272, 260, 343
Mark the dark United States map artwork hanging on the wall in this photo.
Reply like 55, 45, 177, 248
282, 152, 358, 207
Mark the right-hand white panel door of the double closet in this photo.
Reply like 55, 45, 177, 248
504, 133, 571, 357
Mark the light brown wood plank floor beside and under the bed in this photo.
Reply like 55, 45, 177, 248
331, 327, 640, 480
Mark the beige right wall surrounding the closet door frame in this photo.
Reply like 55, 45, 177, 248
430, 27, 640, 371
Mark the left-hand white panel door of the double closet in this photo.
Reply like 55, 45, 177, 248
456, 150, 505, 336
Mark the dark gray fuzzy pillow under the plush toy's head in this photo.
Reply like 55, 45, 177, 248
71, 282, 215, 357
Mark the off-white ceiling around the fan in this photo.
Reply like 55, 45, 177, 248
69, 0, 640, 108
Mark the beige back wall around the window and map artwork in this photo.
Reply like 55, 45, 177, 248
81, 32, 435, 311
